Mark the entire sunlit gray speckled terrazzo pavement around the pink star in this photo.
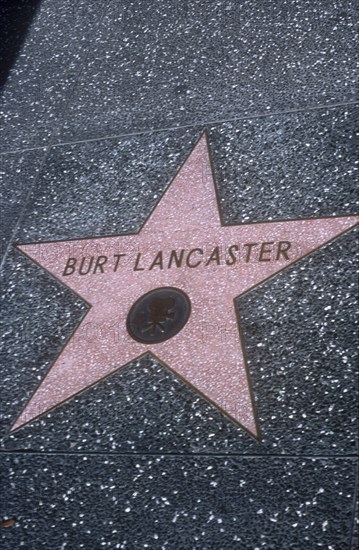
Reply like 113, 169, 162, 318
0, 0, 358, 550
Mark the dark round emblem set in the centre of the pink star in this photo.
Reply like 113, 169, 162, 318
127, 287, 191, 344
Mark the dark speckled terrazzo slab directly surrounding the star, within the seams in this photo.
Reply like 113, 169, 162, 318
1, 108, 357, 455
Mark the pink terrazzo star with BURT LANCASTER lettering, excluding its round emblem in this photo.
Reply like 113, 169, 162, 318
12, 134, 358, 438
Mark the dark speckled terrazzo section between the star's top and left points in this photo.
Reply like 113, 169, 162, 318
17, 129, 198, 242
